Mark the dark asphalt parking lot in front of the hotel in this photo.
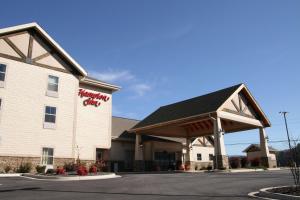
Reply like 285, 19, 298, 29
0, 170, 292, 200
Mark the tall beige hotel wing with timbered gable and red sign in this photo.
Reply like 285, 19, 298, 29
0, 23, 119, 170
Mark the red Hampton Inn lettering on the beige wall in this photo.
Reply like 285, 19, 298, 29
78, 89, 109, 107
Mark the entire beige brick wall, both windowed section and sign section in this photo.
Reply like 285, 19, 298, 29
0, 57, 112, 162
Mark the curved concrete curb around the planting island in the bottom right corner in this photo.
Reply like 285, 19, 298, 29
248, 186, 300, 200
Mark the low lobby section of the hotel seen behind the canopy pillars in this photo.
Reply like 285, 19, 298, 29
109, 117, 214, 171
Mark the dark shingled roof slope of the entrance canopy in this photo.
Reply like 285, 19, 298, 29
133, 84, 242, 129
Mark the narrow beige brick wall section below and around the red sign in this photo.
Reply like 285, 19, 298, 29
76, 84, 112, 160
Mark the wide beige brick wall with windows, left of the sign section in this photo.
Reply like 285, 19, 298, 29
0, 58, 78, 158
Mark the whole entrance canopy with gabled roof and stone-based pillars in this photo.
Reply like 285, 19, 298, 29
130, 84, 271, 169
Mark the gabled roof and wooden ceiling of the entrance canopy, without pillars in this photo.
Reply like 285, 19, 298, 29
131, 84, 271, 138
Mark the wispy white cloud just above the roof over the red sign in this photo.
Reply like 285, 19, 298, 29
90, 70, 135, 82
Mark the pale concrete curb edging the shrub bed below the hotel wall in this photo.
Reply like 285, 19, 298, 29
21, 173, 121, 181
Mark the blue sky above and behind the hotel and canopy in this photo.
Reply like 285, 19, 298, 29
0, 0, 300, 155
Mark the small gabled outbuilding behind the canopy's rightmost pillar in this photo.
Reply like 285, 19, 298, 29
243, 144, 278, 167
